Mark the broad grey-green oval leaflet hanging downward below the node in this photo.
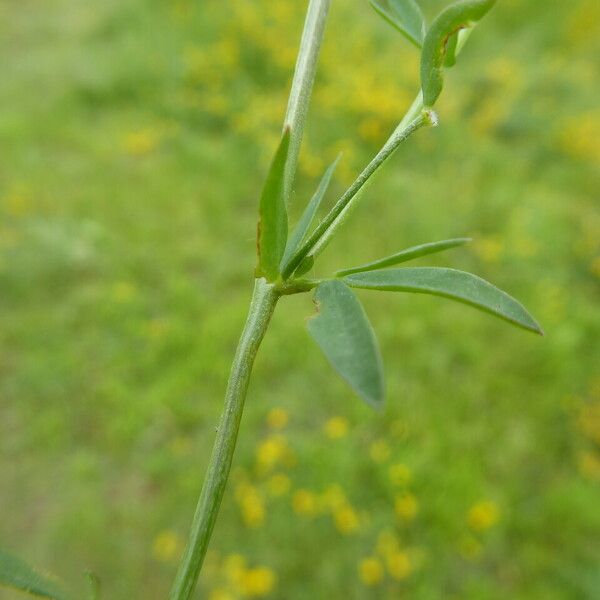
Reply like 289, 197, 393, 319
308, 281, 384, 407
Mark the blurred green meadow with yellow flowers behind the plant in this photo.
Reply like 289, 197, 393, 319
0, 0, 600, 600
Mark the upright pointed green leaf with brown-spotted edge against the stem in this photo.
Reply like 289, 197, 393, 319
256, 129, 290, 281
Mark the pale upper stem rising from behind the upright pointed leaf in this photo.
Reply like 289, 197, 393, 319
283, 0, 331, 202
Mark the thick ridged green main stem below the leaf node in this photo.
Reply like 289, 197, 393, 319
170, 278, 279, 600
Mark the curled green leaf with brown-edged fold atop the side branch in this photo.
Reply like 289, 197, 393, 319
421, 0, 496, 108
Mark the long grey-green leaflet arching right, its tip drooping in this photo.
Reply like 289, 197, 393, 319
343, 267, 543, 335
